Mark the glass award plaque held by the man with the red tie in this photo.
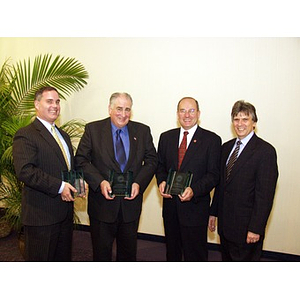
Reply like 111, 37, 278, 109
164, 170, 193, 195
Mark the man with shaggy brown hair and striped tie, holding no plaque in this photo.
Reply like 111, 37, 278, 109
209, 101, 278, 261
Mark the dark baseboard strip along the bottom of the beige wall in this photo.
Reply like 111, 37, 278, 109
74, 224, 300, 262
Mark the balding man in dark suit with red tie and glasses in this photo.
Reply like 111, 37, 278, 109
156, 97, 221, 261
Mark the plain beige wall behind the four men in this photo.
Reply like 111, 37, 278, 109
0, 38, 300, 255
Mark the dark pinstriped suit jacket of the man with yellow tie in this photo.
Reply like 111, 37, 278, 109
13, 119, 74, 226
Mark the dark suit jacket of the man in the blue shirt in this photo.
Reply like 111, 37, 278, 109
75, 118, 157, 223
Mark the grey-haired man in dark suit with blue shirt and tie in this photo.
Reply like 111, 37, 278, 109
75, 93, 157, 261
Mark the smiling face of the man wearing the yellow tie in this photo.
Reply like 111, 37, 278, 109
34, 91, 60, 124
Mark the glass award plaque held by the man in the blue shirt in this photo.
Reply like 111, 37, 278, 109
109, 171, 133, 197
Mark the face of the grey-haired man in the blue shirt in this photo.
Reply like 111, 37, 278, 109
108, 96, 132, 128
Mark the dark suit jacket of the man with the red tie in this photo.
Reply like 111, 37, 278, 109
156, 126, 221, 226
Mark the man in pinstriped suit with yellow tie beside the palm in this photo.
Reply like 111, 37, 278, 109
13, 87, 76, 261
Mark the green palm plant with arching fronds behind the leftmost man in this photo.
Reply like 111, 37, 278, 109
0, 54, 88, 234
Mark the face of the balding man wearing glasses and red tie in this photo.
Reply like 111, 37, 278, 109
177, 98, 200, 130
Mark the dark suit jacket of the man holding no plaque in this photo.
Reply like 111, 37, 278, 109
211, 134, 278, 243
